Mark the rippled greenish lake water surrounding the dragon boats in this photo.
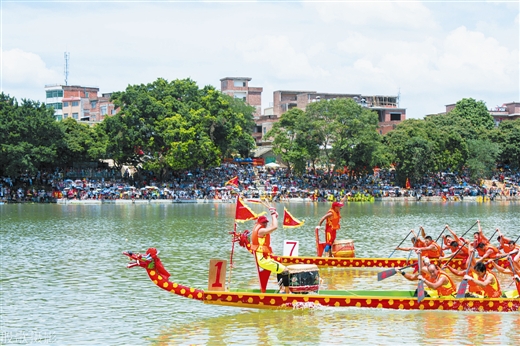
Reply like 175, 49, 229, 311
0, 202, 520, 345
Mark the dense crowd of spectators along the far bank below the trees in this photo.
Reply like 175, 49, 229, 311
0, 163, 520, 203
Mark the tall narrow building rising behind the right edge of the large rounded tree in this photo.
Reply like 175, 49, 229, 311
220, 77, 264, 120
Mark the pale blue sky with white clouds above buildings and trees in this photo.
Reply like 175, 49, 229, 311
0, 0, 520, 119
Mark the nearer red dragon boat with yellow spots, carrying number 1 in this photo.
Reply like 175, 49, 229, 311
123, 248, 520, 312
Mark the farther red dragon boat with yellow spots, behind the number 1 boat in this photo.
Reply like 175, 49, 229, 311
232, 230, 508, 269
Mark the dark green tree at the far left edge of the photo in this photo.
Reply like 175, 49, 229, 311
0, 93, 63, 177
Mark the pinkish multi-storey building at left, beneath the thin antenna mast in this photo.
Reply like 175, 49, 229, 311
45, 84, 116, 124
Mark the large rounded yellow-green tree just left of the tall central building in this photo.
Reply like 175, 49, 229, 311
103, 79, 255, 173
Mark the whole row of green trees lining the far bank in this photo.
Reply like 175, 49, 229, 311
0, 79, 520, 185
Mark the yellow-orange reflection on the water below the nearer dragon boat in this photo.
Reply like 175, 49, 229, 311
151, 308, 519, 345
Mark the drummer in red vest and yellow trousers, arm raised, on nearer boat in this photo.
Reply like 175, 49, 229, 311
251, 207, 289, 293
